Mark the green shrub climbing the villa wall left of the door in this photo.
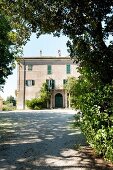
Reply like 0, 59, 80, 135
26, 83, 50, 110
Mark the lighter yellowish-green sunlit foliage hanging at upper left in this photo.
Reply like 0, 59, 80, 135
0, 0, 31, 46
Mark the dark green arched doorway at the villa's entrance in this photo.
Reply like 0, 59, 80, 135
55, 93, 63, 108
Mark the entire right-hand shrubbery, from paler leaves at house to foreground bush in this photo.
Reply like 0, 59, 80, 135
71, 79, 113, 162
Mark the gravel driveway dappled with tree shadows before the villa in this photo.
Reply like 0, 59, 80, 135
0, 109, 112, 170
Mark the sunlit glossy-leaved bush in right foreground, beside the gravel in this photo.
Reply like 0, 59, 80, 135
82, 85, 113, 162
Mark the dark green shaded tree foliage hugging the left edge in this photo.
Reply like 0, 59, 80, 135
0, 14, 14, 85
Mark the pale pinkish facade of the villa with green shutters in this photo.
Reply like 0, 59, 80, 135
17, 56, 79, 109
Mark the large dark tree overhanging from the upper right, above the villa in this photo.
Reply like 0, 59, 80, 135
6, 0, 113, 84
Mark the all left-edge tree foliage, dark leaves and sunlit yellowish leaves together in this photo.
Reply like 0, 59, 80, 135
0, 1, 30, 90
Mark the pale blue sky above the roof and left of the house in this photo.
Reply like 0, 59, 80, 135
0, 34, 69, 99
